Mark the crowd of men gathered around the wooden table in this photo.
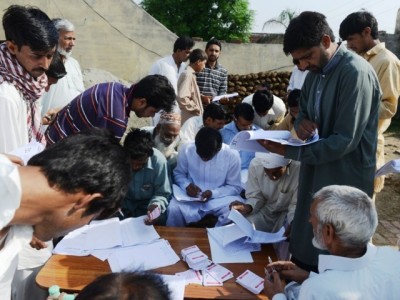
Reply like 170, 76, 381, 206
0, 5, 400, 299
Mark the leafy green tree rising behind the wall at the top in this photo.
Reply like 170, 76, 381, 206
140, 0, 254, 42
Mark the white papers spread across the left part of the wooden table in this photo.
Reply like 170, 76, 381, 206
53, 216, 179, 272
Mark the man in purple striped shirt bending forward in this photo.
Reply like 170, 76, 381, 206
45, 75, 175, 145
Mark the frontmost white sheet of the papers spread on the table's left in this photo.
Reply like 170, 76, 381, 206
108, 239, 180, 272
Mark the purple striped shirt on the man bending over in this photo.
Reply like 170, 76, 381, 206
45, 82, 133, 145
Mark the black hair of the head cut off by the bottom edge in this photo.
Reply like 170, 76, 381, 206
75, 271, 171, 300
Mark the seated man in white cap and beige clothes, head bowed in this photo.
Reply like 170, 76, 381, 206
231, 152, 300, 232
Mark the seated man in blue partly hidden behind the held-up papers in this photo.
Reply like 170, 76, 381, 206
220, 103, 259, 189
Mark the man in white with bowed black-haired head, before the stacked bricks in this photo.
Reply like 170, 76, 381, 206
242, 85, 286, 130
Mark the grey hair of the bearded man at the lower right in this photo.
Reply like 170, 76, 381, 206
314, 185, 378, 247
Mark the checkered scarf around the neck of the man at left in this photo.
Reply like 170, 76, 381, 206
0, 43, 47, 143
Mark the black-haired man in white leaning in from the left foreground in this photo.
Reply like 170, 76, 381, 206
0, 129, 131, 299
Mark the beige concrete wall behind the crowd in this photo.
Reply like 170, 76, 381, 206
0, 0, 291, 82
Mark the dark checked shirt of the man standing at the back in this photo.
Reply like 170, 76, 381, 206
196, 63, 228, 96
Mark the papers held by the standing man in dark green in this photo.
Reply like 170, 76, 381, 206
229, 129, 320, 152
